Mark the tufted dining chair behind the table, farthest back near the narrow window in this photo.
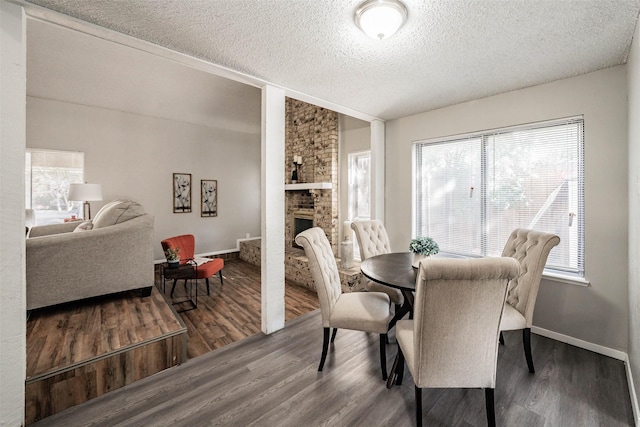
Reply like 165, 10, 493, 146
351, 219, 404, 313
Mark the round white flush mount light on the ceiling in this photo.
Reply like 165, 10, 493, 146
355, 0, 407, 40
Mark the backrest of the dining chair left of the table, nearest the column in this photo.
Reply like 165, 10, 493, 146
296, 227, 342, 328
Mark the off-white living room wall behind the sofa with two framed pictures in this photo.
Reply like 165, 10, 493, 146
27, 97, 260, 259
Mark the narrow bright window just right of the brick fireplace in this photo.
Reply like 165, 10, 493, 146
348, 151, 371, 259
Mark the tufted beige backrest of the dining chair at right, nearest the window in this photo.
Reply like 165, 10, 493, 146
502, 228, 560, 328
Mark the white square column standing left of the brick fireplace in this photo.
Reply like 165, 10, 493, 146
261, 86, 285, 334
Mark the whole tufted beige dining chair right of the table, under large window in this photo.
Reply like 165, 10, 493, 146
500, 228, 560, 374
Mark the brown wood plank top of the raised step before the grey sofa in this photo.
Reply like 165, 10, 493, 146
26, 290, 184, 382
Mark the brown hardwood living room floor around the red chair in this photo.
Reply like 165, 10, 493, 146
165, 259, 320, 359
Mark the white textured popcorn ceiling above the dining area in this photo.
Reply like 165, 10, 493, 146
22, 0, 640, 119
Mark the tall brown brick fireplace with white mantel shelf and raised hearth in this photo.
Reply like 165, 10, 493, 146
240, 98, 362, 292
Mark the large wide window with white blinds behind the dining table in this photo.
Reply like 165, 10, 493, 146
414, 117, 584, 277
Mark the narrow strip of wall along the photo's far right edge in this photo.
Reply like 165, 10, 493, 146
627, 15, 640, 419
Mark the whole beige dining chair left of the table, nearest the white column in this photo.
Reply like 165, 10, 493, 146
296, 227, 391, 379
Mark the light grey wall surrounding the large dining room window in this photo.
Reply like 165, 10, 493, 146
385, 66, 628, 351
